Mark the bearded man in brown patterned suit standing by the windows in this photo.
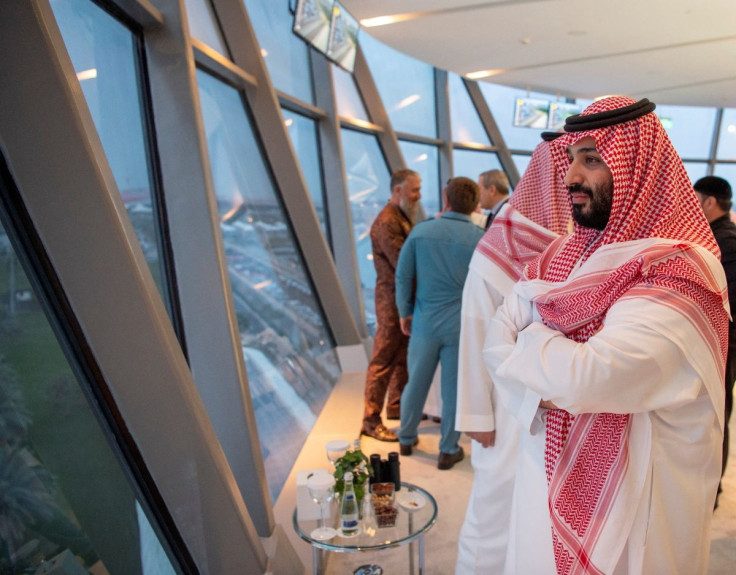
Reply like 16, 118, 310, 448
360, 170, 422, 441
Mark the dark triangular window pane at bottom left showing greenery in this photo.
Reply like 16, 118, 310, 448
0, 224, 174, 574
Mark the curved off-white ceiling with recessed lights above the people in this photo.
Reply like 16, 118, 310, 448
340, 0, 736, 108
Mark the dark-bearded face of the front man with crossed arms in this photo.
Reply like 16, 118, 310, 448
564, 137, 613, 230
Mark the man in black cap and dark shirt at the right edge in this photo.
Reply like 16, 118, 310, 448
693, 176, 736, 505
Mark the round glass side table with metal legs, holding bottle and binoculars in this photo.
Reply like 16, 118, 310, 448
293, 481, 437, 575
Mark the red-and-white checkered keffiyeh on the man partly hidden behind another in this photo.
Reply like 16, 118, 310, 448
476, 141, 572, 281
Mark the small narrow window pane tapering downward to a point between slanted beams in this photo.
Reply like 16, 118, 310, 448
281, 109, 329, 238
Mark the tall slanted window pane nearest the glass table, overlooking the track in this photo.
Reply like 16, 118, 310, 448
197, 71, 340, 501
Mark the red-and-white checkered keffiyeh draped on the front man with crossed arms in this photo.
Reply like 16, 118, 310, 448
528, 97, 727, 575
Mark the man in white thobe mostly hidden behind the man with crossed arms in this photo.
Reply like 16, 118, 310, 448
455, 132, 571, 575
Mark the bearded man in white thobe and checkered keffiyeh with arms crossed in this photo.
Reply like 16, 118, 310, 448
484, 97, 728, 575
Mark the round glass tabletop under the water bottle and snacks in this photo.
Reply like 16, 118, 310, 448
293, 481, 437, 552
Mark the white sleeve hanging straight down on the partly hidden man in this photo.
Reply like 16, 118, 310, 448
455, 266, 503, 431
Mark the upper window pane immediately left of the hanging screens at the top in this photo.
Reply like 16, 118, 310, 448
244, 0, 314, 104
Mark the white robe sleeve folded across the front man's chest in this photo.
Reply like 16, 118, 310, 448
484, 297, 703, 423
